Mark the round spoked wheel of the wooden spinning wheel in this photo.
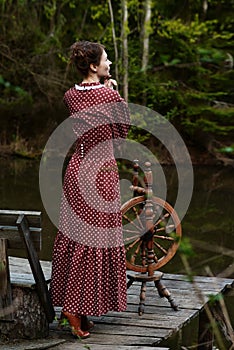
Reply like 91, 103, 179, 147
121, 196, 182, 273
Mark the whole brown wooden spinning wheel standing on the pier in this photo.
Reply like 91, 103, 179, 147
121, 161, 182, 315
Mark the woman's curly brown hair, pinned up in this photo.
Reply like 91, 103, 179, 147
70, 40, 105, 77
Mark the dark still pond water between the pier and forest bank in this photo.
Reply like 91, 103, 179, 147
0, 159, 234, 348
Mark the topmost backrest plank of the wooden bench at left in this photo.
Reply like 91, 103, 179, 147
0, 210, 41, 227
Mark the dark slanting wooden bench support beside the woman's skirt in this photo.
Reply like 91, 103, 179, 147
16, 214, 55, 323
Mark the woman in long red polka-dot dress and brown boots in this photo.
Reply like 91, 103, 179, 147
50, 41, 129, 338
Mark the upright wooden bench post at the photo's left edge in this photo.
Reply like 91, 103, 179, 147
0, 238, 12, 321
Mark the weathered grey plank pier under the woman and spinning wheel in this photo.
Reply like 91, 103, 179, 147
0, 258, 233, 350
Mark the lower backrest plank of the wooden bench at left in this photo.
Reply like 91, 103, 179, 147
0, 226, 42, 252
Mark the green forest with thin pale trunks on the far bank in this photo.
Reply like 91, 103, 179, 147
0, 0, 234, 166
